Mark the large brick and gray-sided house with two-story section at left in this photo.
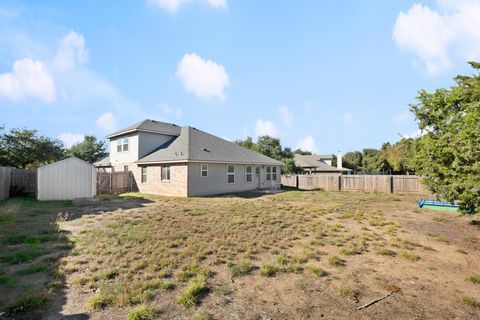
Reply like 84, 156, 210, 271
94, 119, 282, 197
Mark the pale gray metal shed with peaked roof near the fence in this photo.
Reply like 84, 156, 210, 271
37, 157, 97, 200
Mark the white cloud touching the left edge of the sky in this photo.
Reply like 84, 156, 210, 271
0, 59, 56, 102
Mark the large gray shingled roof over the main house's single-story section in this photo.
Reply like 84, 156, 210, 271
136, 126, 282, 165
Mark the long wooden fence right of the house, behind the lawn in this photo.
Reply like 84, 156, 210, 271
281, 174, 427, 193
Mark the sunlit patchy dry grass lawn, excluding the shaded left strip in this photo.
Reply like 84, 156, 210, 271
0, 191, 480, 319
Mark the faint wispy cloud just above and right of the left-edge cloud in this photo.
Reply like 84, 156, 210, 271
52, 31, 88, 70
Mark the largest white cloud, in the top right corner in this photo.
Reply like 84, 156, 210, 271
393, 0, 480, 75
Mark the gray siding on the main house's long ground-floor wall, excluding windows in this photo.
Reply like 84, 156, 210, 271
188, 163, 280, 196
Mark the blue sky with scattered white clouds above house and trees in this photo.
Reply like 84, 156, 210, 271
0, 0, 480, 153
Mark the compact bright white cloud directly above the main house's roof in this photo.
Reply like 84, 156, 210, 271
175, 53, 230, 101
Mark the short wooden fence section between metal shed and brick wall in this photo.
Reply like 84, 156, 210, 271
97, 171, 135, 194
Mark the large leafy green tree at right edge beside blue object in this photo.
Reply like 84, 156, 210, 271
411, 62, 480, 211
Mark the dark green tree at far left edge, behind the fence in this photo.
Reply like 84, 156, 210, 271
0, 128, 64, 168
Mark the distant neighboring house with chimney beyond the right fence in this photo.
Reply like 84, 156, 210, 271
294, 154, 352, 174
